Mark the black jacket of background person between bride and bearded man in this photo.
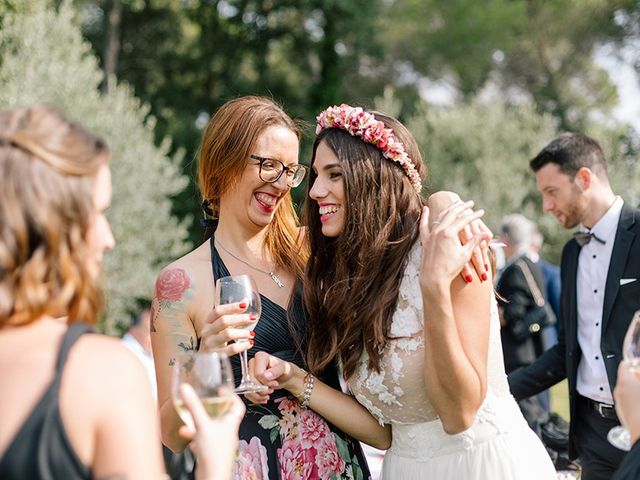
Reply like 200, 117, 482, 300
496, 255, 545, 373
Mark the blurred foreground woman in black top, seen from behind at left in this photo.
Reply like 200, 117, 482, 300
0, 106, 243, 480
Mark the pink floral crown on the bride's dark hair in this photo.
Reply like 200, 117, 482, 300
316, 103, 422, 193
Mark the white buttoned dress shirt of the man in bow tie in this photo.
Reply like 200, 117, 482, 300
576, 197, 623, 405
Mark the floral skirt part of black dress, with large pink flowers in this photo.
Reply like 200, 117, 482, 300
233, 396, 370, 480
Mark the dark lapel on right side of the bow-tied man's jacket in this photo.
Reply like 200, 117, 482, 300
602, 203, 635, 332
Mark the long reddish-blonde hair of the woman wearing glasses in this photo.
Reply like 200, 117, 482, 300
198, 96, 308, 278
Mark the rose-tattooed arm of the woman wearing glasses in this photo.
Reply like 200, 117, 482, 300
151, 266, 197, 452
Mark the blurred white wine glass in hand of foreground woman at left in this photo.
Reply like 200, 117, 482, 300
171, 351, 234, 428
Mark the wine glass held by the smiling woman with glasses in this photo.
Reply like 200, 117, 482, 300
216, 275, 268, 393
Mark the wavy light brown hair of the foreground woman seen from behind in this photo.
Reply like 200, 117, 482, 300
0, 105, 109, 328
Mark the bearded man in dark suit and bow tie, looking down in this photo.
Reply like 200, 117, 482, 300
509, 133, 640, 480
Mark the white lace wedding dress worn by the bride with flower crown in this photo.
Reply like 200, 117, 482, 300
347, 242, 556, 480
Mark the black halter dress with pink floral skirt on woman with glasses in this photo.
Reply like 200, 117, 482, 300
210, 237, 370, 480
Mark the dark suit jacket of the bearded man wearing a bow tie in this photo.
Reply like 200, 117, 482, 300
509, 203, 640, 459
